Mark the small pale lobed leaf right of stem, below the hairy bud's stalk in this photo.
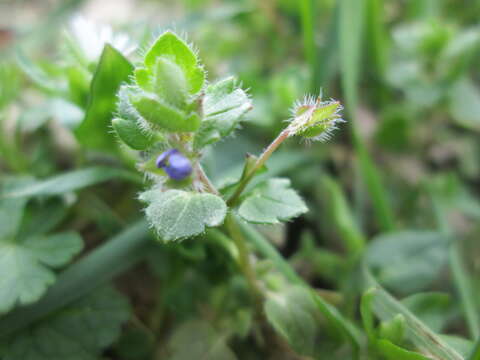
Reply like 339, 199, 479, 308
238, 179, 308, 224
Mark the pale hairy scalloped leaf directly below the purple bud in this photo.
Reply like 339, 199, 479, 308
140, 190, 227, 241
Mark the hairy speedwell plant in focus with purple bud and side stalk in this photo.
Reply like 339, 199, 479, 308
112, 31, 342, 241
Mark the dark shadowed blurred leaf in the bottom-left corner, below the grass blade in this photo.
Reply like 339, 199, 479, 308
3, 288, 130, 360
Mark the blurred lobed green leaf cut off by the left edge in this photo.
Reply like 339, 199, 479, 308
0, 232, 83, 313
